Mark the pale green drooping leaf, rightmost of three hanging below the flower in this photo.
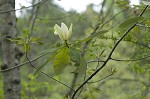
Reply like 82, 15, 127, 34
77, 57, 87, 74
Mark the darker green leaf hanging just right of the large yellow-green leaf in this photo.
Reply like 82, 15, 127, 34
69, 47, 80, 66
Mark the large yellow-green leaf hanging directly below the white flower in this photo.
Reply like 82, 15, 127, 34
53, 47, 70, 74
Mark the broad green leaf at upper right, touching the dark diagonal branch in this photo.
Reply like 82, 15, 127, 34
119, 17, 142, 28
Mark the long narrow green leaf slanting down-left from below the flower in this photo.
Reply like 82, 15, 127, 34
34, 51, 57, 75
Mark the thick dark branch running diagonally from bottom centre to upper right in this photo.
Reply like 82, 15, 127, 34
71, 5, 148, 99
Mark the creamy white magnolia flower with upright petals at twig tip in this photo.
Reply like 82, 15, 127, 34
54, 23, 73, 41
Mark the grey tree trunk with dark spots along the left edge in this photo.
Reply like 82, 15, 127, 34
0, 0, 22, 99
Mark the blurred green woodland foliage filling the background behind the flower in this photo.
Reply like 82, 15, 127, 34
0, 0, 150, 99
